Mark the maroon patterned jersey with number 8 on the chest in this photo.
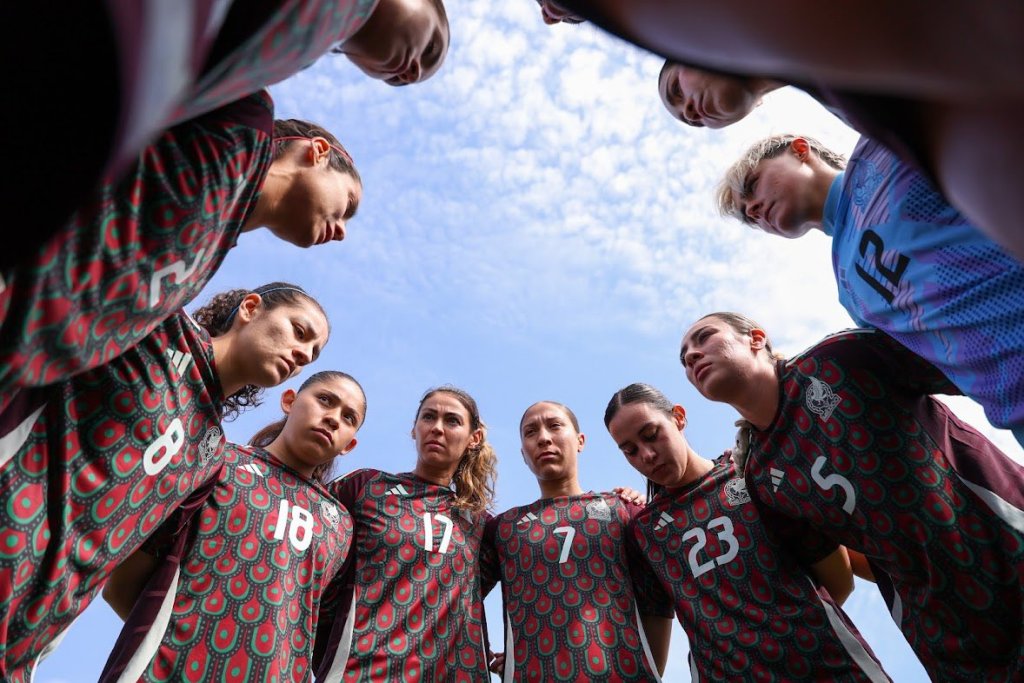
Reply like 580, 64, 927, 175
0, 311, 224, 681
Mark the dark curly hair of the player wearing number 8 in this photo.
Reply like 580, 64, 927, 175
193, 283, 330, 420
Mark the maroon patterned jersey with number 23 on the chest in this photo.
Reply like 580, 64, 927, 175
630, 457, 889, 683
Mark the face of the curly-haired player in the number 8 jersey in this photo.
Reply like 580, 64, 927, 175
234, 300, 329, 387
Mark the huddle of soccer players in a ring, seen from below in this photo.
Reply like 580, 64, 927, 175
0, 0, 1024, 683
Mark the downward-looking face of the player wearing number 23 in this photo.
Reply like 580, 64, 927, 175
608, 403, 693, 488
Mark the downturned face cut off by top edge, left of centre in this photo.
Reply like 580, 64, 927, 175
338, 0, 449, 85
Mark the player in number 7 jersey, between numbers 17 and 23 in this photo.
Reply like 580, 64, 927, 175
480, 401, 672, 681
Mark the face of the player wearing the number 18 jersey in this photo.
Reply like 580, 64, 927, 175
281, 378, 365, 467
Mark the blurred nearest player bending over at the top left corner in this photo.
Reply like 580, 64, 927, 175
7, 0, 450, 271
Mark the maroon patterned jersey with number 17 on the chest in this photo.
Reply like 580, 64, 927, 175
315, 469, 489, 683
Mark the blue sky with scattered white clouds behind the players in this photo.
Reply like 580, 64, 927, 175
37, 0, 1024, 683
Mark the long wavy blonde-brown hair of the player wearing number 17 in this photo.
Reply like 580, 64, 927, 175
416, 384, 498, 513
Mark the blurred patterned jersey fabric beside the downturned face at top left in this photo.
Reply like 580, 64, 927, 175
174, 0, 378, 121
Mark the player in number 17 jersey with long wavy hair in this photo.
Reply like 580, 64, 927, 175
314, 385, 497, 683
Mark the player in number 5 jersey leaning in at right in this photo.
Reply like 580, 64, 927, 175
680, 312, 1024, 681
